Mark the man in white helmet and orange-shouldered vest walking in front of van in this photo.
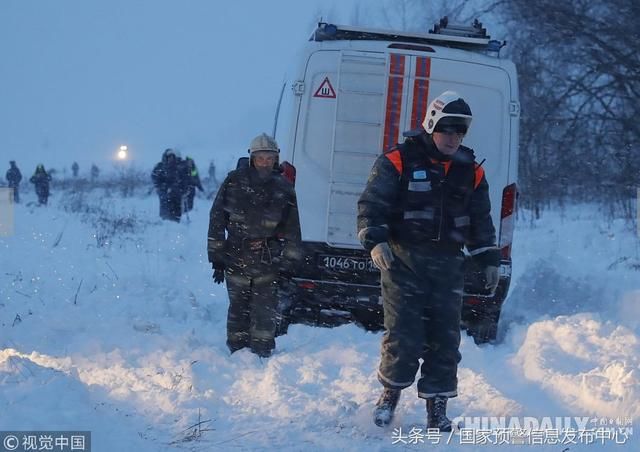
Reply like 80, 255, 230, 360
358, 91, 500, 431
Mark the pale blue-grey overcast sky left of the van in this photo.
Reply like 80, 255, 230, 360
0, 0, 356, 174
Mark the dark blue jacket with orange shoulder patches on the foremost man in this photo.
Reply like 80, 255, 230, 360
358, 134, 496, 254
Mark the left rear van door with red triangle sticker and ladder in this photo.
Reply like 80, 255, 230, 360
292, 50, 387, 248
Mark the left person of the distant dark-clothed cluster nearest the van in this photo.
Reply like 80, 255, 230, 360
151, 148, 184, 222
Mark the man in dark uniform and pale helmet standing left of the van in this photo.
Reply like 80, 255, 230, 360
207, 134, 300, 357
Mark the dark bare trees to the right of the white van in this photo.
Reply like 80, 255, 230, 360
502, 0, 640, 210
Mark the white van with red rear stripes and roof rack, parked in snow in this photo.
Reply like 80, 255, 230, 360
281, 18, 520, 342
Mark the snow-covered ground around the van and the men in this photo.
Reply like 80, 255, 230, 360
0, 191, 640, 451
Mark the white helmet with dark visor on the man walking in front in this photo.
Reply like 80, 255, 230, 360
422, 91, 472, 134
